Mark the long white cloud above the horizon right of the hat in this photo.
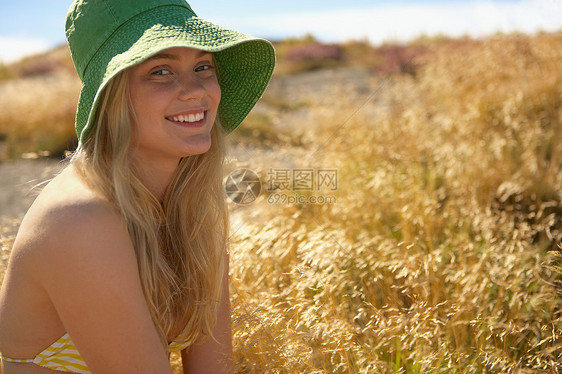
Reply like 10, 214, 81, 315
240, 0, 562, 43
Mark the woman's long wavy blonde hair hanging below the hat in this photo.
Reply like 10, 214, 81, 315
73, 71, 228, 345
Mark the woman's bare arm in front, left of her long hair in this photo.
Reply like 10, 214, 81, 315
27, 201, 172, 374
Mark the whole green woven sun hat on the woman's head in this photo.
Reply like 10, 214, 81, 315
66, 0, 275, 143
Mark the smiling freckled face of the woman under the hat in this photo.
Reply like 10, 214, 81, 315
129, 47, 221, 162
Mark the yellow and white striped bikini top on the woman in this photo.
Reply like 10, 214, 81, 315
0, 334, 189, 374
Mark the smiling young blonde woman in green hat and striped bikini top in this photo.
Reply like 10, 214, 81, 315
0, 0, 275, 374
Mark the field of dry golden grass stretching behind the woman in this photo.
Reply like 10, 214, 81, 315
0, 34, 562, 373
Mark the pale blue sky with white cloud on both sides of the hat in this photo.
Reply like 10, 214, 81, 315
0, 0, 562, 61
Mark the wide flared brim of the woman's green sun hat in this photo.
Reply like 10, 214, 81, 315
76, 6, 275, 143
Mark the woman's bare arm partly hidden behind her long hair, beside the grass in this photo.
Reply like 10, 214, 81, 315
181, 255, 232, 374
